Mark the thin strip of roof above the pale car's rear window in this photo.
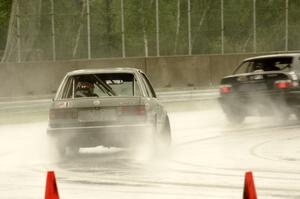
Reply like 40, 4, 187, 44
67, 67, 141, 76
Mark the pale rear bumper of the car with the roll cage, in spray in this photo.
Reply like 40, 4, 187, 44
47, 123, 154, 147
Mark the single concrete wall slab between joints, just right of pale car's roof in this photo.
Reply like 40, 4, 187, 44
146, 56, 211, 88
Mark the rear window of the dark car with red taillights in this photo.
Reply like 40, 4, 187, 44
234, 57, 292, 74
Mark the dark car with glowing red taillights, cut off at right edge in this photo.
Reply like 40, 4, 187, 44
219, 53, 300, 123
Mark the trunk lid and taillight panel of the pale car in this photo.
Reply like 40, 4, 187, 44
49, 97, 146, 124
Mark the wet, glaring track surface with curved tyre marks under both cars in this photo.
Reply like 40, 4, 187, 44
0, 103, 300, 199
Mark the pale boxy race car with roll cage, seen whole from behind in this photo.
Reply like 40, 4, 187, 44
47, 68, 171, 155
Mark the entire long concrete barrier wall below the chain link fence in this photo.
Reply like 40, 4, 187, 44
0, 54, 262, 97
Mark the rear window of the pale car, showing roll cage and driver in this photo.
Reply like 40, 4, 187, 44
62, 73, 141, 98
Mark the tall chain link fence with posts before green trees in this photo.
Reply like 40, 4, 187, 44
2, 0, 300, 62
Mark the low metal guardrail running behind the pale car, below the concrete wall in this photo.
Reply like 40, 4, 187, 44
0, 89, 219, 112
